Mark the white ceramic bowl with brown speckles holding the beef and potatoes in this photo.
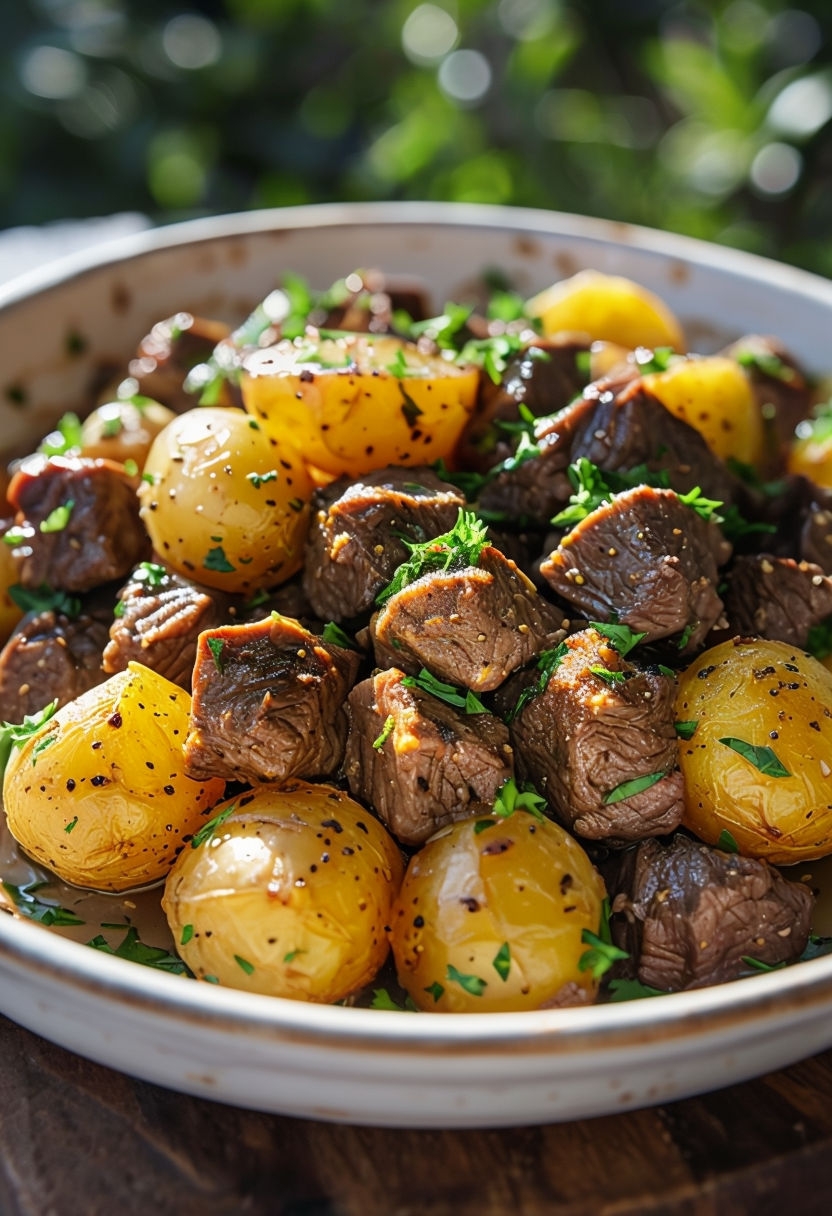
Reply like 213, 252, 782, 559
0, 203, 832, 1127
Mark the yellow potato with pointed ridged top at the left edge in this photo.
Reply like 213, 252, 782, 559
2, 663, 225, 891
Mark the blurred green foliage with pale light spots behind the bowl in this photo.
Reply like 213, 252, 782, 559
0, 0, 832, 274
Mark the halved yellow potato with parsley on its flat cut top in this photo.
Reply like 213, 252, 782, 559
241, 334, 479, 477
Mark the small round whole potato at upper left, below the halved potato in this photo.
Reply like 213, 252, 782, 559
139, 406, 311, 595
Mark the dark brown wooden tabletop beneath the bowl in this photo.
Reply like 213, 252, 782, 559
0, 1019, 832, 1216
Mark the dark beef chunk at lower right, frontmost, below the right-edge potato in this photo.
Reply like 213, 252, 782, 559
605, 832, 814, 992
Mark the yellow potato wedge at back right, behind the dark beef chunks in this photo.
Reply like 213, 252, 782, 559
642, 355, 763, 465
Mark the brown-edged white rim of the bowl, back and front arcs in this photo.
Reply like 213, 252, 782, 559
0, 202, 832, 1053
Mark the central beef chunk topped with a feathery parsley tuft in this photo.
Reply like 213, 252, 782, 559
371, 545, 568, 692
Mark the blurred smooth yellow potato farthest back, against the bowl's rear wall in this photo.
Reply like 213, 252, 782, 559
525, 270, 685, 350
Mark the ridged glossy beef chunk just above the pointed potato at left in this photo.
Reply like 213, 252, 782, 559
103, 562, 238, 691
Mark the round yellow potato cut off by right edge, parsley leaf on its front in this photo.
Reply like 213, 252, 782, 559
676, 638, 832, 866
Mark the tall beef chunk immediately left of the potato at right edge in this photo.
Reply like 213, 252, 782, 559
496, 629, 684, 845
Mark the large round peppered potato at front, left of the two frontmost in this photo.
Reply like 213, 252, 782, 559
162, 781, 404, 1003
